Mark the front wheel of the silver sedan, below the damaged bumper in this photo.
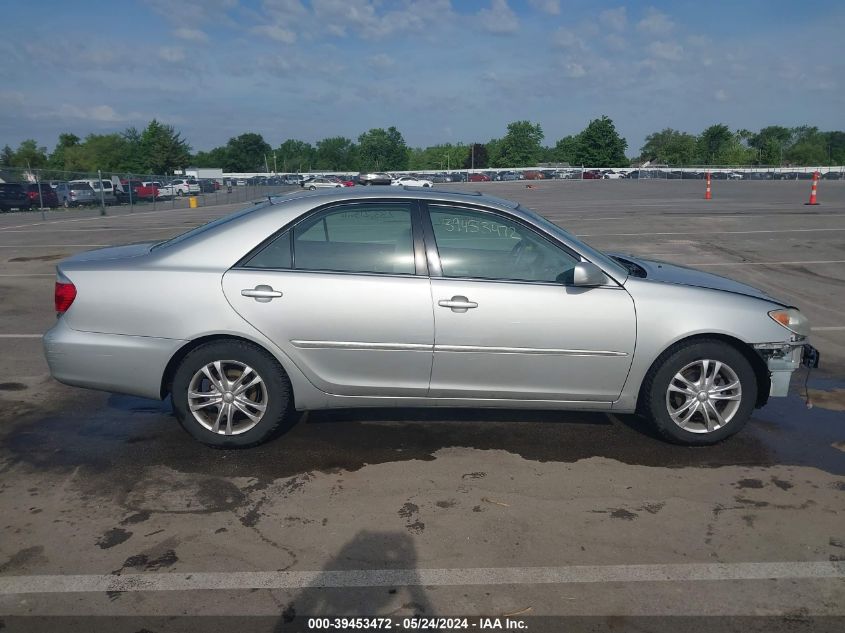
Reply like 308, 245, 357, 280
640, 339, 757, 446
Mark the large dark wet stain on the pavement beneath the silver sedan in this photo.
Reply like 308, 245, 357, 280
0, 383, 845, 494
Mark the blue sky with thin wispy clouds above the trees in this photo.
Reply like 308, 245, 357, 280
0, 0, 845, 155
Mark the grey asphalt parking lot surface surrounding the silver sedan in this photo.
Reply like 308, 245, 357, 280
0, 180, 845, 630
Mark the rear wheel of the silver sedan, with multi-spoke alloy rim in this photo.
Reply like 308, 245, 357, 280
171, 340, 293, 449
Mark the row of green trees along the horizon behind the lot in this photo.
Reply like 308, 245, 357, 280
0, 116, 845, 174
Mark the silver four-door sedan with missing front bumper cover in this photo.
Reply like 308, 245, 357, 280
44, 187, 818, 447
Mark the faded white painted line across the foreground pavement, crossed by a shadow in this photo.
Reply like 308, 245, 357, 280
0, 561, 845, 595
